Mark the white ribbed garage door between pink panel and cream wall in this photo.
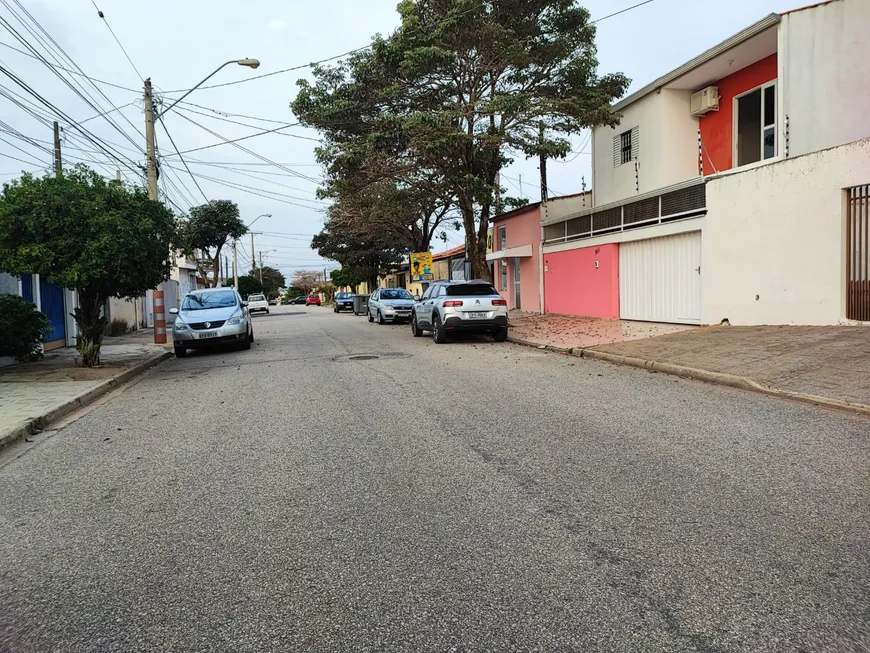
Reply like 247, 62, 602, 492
619, 231, 701, 324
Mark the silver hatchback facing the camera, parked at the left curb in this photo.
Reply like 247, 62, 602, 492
169, 288, 254, 358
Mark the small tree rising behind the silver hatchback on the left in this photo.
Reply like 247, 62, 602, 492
178, 200, 248, 288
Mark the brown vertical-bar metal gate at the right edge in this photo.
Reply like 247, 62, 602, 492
846, 184, 870, 322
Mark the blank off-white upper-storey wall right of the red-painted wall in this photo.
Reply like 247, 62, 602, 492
780, 0, 870, 156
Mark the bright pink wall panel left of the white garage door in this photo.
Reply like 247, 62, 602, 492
544, 243, 619, 318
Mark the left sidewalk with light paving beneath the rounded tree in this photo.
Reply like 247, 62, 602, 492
0, 329, 172, 448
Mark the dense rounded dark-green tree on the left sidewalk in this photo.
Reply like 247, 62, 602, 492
0, 165, 176, 367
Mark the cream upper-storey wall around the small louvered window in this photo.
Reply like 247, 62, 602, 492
592, 89, 698, 206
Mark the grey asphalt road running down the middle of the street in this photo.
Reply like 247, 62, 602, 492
0, 307, 870, 653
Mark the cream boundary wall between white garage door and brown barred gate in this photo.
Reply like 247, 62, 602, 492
701, 139, 870, 325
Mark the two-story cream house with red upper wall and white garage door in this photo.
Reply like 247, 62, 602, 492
541, 0, 870, 324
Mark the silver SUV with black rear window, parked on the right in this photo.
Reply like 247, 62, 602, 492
411, 280, 508, 344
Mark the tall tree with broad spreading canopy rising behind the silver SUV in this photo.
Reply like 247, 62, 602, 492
292, 0, 629, 277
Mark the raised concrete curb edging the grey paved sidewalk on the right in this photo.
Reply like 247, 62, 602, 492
573, 349, 870, 416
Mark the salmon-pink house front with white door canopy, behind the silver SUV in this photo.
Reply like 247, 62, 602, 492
492, 207, 541, 313
